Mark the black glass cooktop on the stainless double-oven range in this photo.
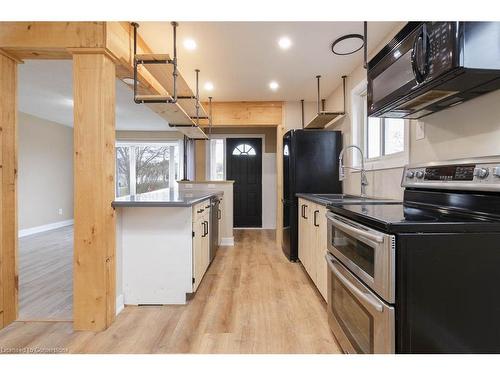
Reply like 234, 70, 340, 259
328, 203, 500, 233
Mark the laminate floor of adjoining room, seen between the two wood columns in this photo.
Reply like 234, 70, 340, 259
19, 226, 73, 320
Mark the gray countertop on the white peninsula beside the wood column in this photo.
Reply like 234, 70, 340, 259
112, 189, 224, 207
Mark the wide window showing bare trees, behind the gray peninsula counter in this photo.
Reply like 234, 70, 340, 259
116, 141, 182, 197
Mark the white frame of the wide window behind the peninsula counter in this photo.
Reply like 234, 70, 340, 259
115, 139, 184, 195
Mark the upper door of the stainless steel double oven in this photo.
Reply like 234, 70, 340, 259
326, 212, 395, 303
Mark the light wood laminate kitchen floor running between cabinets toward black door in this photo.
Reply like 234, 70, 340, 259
0, 230, 339, 353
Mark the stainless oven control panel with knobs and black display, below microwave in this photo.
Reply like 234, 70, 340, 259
401, 160, 500, 191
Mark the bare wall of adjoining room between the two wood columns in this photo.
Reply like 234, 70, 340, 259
18, 112, 73, 232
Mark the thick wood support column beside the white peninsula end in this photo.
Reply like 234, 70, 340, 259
72, 50, 116, 331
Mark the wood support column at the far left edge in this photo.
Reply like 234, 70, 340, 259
0, 54, 18, 328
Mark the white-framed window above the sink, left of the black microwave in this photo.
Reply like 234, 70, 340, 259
352, 82, 409, 169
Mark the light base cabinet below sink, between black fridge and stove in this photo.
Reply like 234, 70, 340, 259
298, 198, 328, 300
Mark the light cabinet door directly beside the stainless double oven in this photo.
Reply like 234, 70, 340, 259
315, 205, 328, 301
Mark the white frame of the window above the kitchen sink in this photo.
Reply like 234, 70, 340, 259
351, 80, 410, 171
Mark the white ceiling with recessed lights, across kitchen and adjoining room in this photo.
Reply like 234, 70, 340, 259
19, 22, 397, 130
